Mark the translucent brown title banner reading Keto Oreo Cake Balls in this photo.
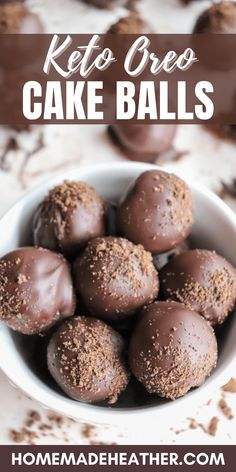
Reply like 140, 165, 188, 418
0, 34, 236, 125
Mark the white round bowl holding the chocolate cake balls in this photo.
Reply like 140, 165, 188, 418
0, 162, 236, 427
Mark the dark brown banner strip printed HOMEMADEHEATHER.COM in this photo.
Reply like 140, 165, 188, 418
0, 445, 236, 472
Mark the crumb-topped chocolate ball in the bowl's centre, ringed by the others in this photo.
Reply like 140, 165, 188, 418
74, 236, 159, 321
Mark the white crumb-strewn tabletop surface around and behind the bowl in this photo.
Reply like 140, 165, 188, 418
0, 0, 236, 444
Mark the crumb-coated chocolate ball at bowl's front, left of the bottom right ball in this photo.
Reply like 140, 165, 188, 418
47, 316, 129, 403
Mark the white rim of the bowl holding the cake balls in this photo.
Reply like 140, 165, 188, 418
0, 161, 236, 426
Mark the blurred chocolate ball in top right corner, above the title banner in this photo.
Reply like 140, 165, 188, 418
193, 1, 236, 34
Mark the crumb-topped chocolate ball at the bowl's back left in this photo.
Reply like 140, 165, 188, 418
33, 181, 105, 257
